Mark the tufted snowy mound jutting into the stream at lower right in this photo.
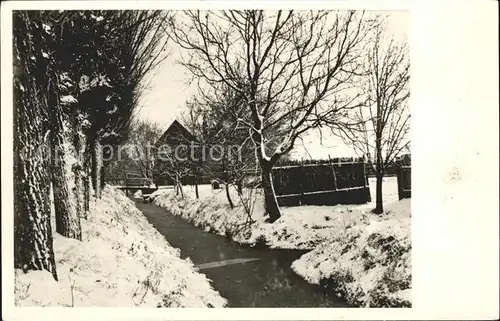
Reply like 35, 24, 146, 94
292, 200, 412, 307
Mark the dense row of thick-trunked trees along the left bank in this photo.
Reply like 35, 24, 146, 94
13, 11, 170, 279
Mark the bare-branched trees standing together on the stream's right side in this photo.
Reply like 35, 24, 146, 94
164, 10, 410, 222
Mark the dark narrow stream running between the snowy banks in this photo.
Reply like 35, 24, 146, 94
136, 202, 347, 307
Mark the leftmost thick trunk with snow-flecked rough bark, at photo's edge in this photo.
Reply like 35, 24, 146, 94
13, 11, 57, 280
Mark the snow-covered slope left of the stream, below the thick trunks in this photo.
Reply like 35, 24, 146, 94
15, 187, 227, 307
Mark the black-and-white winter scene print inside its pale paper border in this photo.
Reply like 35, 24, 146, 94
2, 3, 498, 318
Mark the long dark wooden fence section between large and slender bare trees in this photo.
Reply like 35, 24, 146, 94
273, 159, 371, 206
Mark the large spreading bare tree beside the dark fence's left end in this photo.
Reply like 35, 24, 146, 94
173, 10, 376, 222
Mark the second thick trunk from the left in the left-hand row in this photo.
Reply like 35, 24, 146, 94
48, 75, 82, 241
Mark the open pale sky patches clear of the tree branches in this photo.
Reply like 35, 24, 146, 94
137, 11, 409, 158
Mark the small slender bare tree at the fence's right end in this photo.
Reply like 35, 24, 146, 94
335, 25, 410, 214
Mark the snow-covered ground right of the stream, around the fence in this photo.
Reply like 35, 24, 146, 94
155, 177, 411, 307
